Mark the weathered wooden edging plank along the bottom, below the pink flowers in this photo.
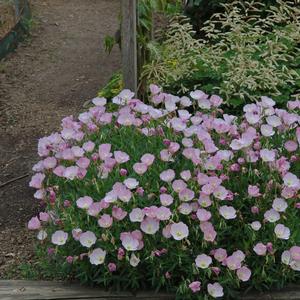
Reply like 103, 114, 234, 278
0, 280, 300, 300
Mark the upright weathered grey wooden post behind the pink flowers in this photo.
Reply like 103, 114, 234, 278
121, 0, 137, 93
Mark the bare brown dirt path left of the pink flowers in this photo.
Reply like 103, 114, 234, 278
0, 0, 120, 278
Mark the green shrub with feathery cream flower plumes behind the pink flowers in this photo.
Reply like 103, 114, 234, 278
143, 0, 300, 107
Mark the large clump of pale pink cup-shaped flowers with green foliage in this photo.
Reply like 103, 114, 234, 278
28, 85, 300, 299
